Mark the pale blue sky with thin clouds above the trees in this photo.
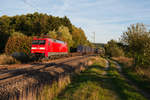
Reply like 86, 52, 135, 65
0, 0, 150, 43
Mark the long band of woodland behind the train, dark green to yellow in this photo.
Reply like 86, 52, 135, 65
0, 12, 91, 52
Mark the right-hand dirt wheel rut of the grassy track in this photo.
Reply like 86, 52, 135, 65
113, 61, 150, 100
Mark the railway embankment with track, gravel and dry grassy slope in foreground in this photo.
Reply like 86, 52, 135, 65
0, 56, 92, 100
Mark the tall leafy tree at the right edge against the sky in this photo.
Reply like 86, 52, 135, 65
121, 23, 150, 67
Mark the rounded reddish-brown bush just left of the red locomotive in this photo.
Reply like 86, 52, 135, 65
5, 32, 32, 55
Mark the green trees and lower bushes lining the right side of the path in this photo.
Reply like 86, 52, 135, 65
105, 23, 150, 67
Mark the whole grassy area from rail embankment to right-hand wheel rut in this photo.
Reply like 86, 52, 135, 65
54, 58, 147, 100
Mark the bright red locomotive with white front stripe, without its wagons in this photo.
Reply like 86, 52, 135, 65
31, 38, 68, 57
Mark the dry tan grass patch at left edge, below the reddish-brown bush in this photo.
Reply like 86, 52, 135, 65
0, 54, 19, 65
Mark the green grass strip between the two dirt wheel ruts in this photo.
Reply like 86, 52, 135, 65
107, 62, 147, 100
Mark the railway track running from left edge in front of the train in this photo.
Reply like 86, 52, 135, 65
0, 56, 86, 87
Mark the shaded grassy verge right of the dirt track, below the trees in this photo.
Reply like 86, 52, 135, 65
114, 58, 150, 93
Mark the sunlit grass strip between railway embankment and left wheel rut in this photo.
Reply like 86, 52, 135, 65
54, 58, 120, 100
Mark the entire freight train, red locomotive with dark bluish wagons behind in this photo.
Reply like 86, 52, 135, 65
31, 38, 100, 58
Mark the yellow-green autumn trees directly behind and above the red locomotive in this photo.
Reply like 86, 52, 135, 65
47, 25, 91, 48
